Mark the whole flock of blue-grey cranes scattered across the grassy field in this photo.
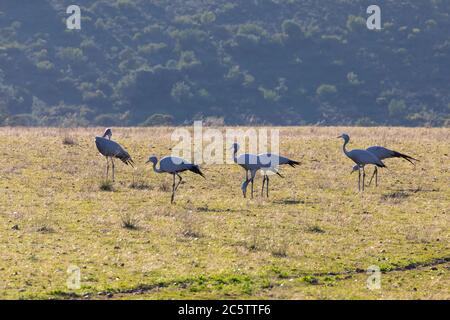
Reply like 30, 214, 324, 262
95, 128, 419, 203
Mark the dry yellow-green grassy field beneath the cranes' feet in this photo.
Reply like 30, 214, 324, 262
0, 127, 450, 299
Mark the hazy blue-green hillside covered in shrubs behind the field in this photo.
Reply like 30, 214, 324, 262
0, 0, 450, 126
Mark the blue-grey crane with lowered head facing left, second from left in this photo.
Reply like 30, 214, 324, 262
146, 156, 205, 203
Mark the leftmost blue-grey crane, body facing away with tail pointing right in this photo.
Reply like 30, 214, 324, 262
95, 128, 134, 181
